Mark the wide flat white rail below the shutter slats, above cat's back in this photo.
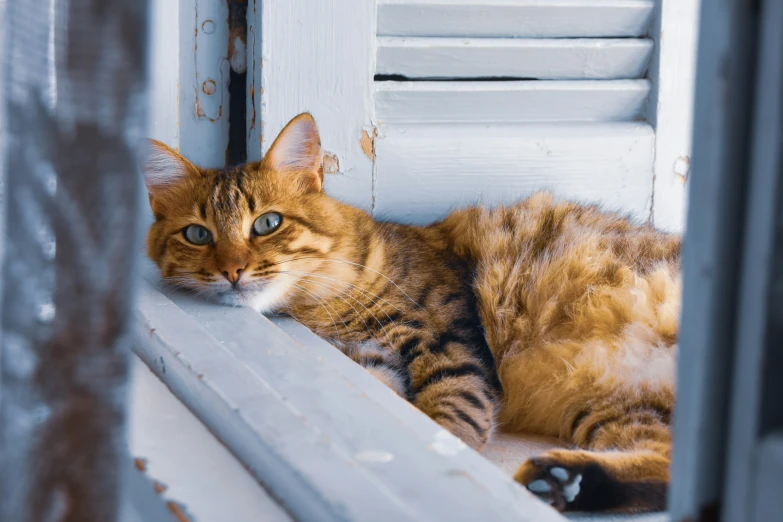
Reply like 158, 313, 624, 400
374, 122, 654, 224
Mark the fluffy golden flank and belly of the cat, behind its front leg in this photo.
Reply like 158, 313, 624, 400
443, 194, 680, 438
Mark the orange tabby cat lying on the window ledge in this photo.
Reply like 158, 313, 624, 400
143, 113, 681, 512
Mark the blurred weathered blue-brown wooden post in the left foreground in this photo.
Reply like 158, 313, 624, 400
0, 0, 148, 522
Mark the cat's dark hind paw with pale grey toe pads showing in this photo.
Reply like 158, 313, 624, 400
514, 457, 583, 511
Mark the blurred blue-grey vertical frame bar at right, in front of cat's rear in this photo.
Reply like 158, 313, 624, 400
664, 2, 760, 512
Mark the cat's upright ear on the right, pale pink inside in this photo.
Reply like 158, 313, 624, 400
263, 112, 324, 192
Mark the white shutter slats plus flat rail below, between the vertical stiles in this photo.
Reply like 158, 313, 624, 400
374, 0, 654, 222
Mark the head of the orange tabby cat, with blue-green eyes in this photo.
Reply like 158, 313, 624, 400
143, 114, 362, 312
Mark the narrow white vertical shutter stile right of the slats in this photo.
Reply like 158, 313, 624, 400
648, 0, 700, 232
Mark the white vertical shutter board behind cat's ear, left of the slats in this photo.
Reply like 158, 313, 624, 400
256, 0, 376, 209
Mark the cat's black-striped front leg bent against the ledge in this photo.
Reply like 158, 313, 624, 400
403, 334, 498, 450
